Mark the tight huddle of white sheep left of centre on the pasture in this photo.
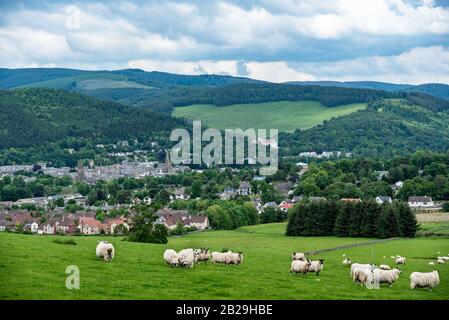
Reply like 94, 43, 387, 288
164, 248, 243, 268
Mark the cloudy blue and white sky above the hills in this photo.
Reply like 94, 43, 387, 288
0, 0, 449, 84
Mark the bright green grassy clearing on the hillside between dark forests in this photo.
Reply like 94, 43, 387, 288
173, 101, 366, 132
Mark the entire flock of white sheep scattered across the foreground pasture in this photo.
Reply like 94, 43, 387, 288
96, 241, 440, 291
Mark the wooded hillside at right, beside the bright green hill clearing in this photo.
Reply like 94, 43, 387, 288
280, 100, 449, 157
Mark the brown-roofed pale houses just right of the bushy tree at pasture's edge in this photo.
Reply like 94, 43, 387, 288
156, 208, 209, 230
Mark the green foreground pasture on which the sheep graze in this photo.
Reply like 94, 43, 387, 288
0, 224, 449, 300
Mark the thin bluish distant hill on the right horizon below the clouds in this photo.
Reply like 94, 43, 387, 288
286, 81, 449, 99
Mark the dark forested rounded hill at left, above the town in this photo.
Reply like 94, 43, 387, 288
0, 88, 185, 149
